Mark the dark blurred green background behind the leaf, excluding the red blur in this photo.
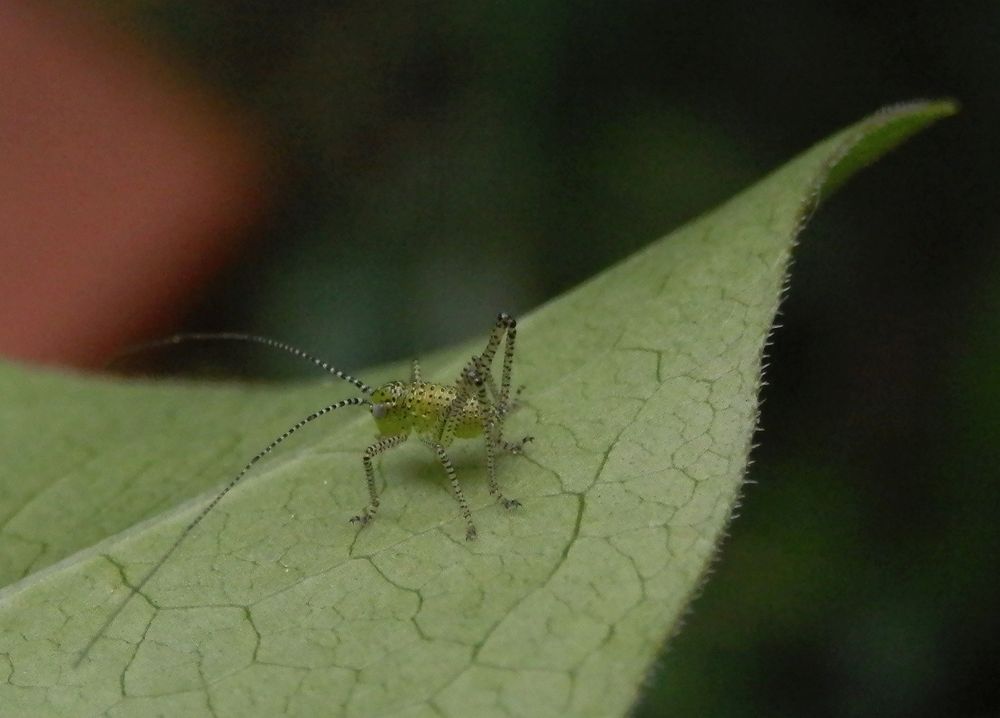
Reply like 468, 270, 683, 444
84, 0, 1000, 717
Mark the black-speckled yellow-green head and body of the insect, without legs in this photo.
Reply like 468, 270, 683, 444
372, 381, 490, 446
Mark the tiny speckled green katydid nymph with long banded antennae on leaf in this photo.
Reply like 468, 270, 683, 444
77, 313, 532, 665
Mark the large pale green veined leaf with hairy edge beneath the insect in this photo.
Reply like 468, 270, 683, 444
0, 103, 954, 716
